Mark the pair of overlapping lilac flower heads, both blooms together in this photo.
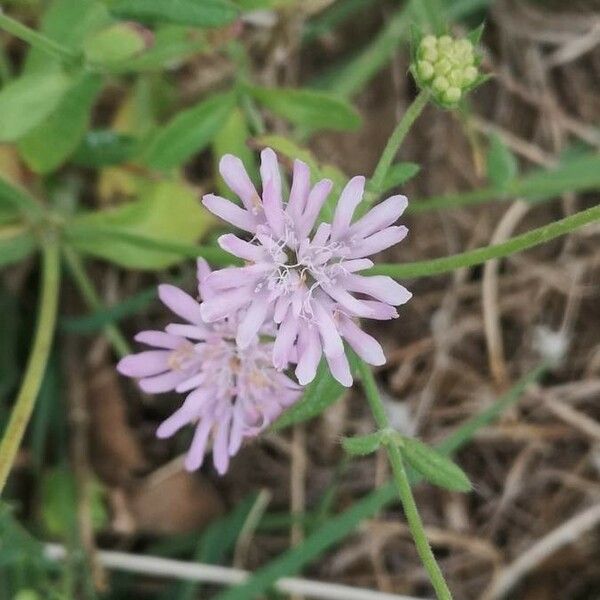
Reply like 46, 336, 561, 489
118, 148, 411, 473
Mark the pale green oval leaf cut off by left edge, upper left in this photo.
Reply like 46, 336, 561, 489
0, 71, 71, 142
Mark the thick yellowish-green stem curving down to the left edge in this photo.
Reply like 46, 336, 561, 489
0, 240, 60, 494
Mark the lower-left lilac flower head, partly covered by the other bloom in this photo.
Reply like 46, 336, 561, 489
117, 260, 300, 474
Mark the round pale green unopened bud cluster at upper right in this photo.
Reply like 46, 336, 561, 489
413, 35, 479, 106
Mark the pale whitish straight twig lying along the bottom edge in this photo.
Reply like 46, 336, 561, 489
45, 544, 423, 600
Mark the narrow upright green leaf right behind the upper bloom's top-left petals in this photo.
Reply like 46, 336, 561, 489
213, 108, 258, 201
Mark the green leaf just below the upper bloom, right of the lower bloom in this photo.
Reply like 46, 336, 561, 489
273, 360, 347, 431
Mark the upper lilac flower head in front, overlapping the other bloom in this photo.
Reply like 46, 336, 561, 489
201, 148, 411, 386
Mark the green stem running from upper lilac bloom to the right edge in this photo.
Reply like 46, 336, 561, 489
365, 204, 600, 279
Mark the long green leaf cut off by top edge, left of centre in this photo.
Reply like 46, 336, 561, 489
109, 0, 239, 27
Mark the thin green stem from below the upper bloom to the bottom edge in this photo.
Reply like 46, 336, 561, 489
357, 359, 452, 600
